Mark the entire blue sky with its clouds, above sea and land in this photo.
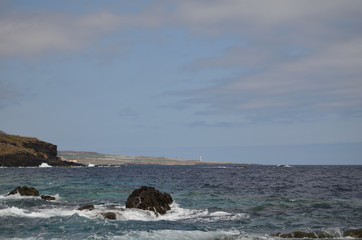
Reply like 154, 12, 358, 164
0, 0, 362, 164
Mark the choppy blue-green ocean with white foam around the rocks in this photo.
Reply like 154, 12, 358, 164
0, 165, 362, 240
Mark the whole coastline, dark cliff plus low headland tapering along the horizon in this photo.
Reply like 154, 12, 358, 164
0, 131, 249, 167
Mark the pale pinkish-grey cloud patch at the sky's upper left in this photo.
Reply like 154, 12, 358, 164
0, 12, 120, 57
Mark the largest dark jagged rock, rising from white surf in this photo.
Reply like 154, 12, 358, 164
126, 186, 173, 214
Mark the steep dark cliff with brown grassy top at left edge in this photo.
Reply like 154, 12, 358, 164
0, 131, 79, 167
